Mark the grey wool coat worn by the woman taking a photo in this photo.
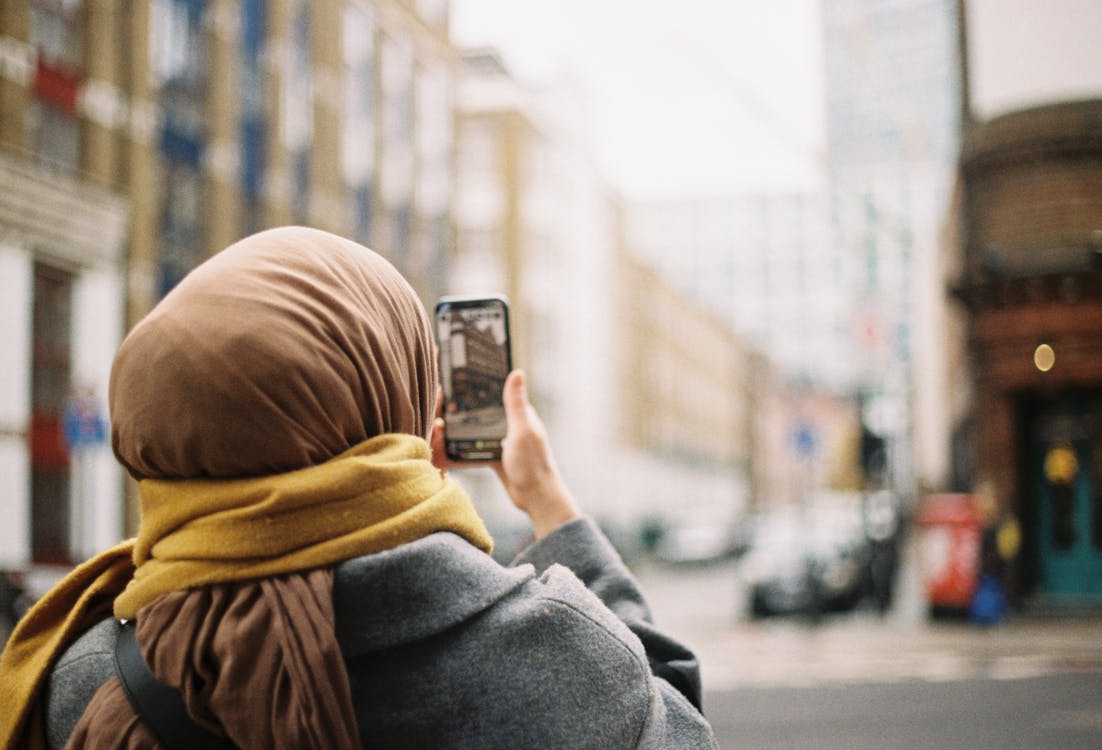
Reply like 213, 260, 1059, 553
47, 519, 716, 750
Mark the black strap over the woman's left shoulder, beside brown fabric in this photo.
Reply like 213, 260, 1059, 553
115, 620, 234, 750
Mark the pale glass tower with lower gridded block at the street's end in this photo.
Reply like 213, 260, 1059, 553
628, 0, 959, 500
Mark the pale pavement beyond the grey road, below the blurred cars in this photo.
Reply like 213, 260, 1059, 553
633, 533, 1102, 691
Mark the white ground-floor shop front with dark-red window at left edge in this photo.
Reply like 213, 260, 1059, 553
0, 151, 127, 594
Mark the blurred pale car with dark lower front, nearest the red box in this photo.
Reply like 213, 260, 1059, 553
739, 508, 867, 618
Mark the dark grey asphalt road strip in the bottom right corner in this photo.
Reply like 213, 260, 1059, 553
704, 672, 1102, 750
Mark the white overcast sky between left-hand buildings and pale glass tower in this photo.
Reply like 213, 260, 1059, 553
452, 0, 823, 198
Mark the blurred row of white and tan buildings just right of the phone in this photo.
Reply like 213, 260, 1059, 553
458, 50, 748, 548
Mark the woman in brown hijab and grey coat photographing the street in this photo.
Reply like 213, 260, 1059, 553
0, 228, 714, 749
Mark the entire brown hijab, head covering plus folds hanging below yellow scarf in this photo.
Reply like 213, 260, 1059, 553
68, 227, 436, 750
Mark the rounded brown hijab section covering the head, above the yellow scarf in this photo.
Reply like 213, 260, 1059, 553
110, 227, 436, 479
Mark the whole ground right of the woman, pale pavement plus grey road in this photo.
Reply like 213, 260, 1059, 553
636, 537, 1102, 750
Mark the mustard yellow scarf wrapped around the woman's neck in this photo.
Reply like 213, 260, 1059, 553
0, 434, 491, 748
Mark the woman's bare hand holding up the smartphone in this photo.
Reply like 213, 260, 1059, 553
430, 370, 582, 539
